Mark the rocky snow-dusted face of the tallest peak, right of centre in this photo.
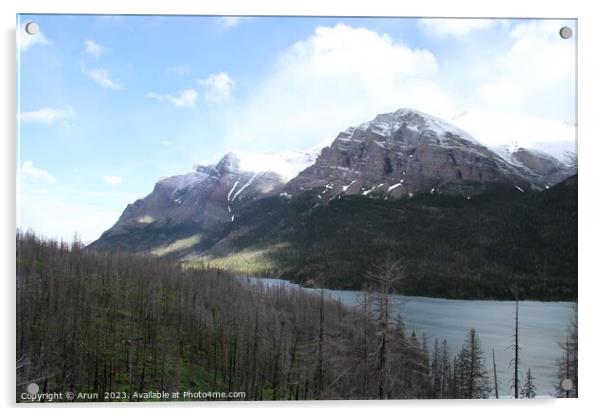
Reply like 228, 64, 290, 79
285, 109, 571, 200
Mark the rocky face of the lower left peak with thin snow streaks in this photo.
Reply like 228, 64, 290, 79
91, 153, 284, 248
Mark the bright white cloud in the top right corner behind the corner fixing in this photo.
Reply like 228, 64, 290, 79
438, 20, 576, 147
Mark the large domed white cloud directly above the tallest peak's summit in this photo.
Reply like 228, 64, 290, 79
226, 24, 442, 150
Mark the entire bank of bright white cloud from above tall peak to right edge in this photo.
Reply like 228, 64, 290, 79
224, 21, 575, 154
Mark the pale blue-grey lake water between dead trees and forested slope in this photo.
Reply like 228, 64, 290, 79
239, 278, 576, 396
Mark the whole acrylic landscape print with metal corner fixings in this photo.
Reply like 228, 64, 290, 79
16, 14, 578, 403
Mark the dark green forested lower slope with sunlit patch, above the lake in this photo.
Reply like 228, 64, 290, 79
189, 176, 577, 300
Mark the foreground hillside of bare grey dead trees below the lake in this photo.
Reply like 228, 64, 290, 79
16, 233, 552, 401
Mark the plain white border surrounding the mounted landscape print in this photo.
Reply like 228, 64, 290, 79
0, 0, 602, 416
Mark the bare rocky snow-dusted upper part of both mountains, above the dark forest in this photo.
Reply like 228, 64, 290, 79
91, 109, 576, 251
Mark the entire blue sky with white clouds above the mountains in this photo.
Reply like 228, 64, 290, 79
17, 15, 576, 242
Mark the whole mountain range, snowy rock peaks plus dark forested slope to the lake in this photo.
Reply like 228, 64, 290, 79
89, 109, 577, 299
